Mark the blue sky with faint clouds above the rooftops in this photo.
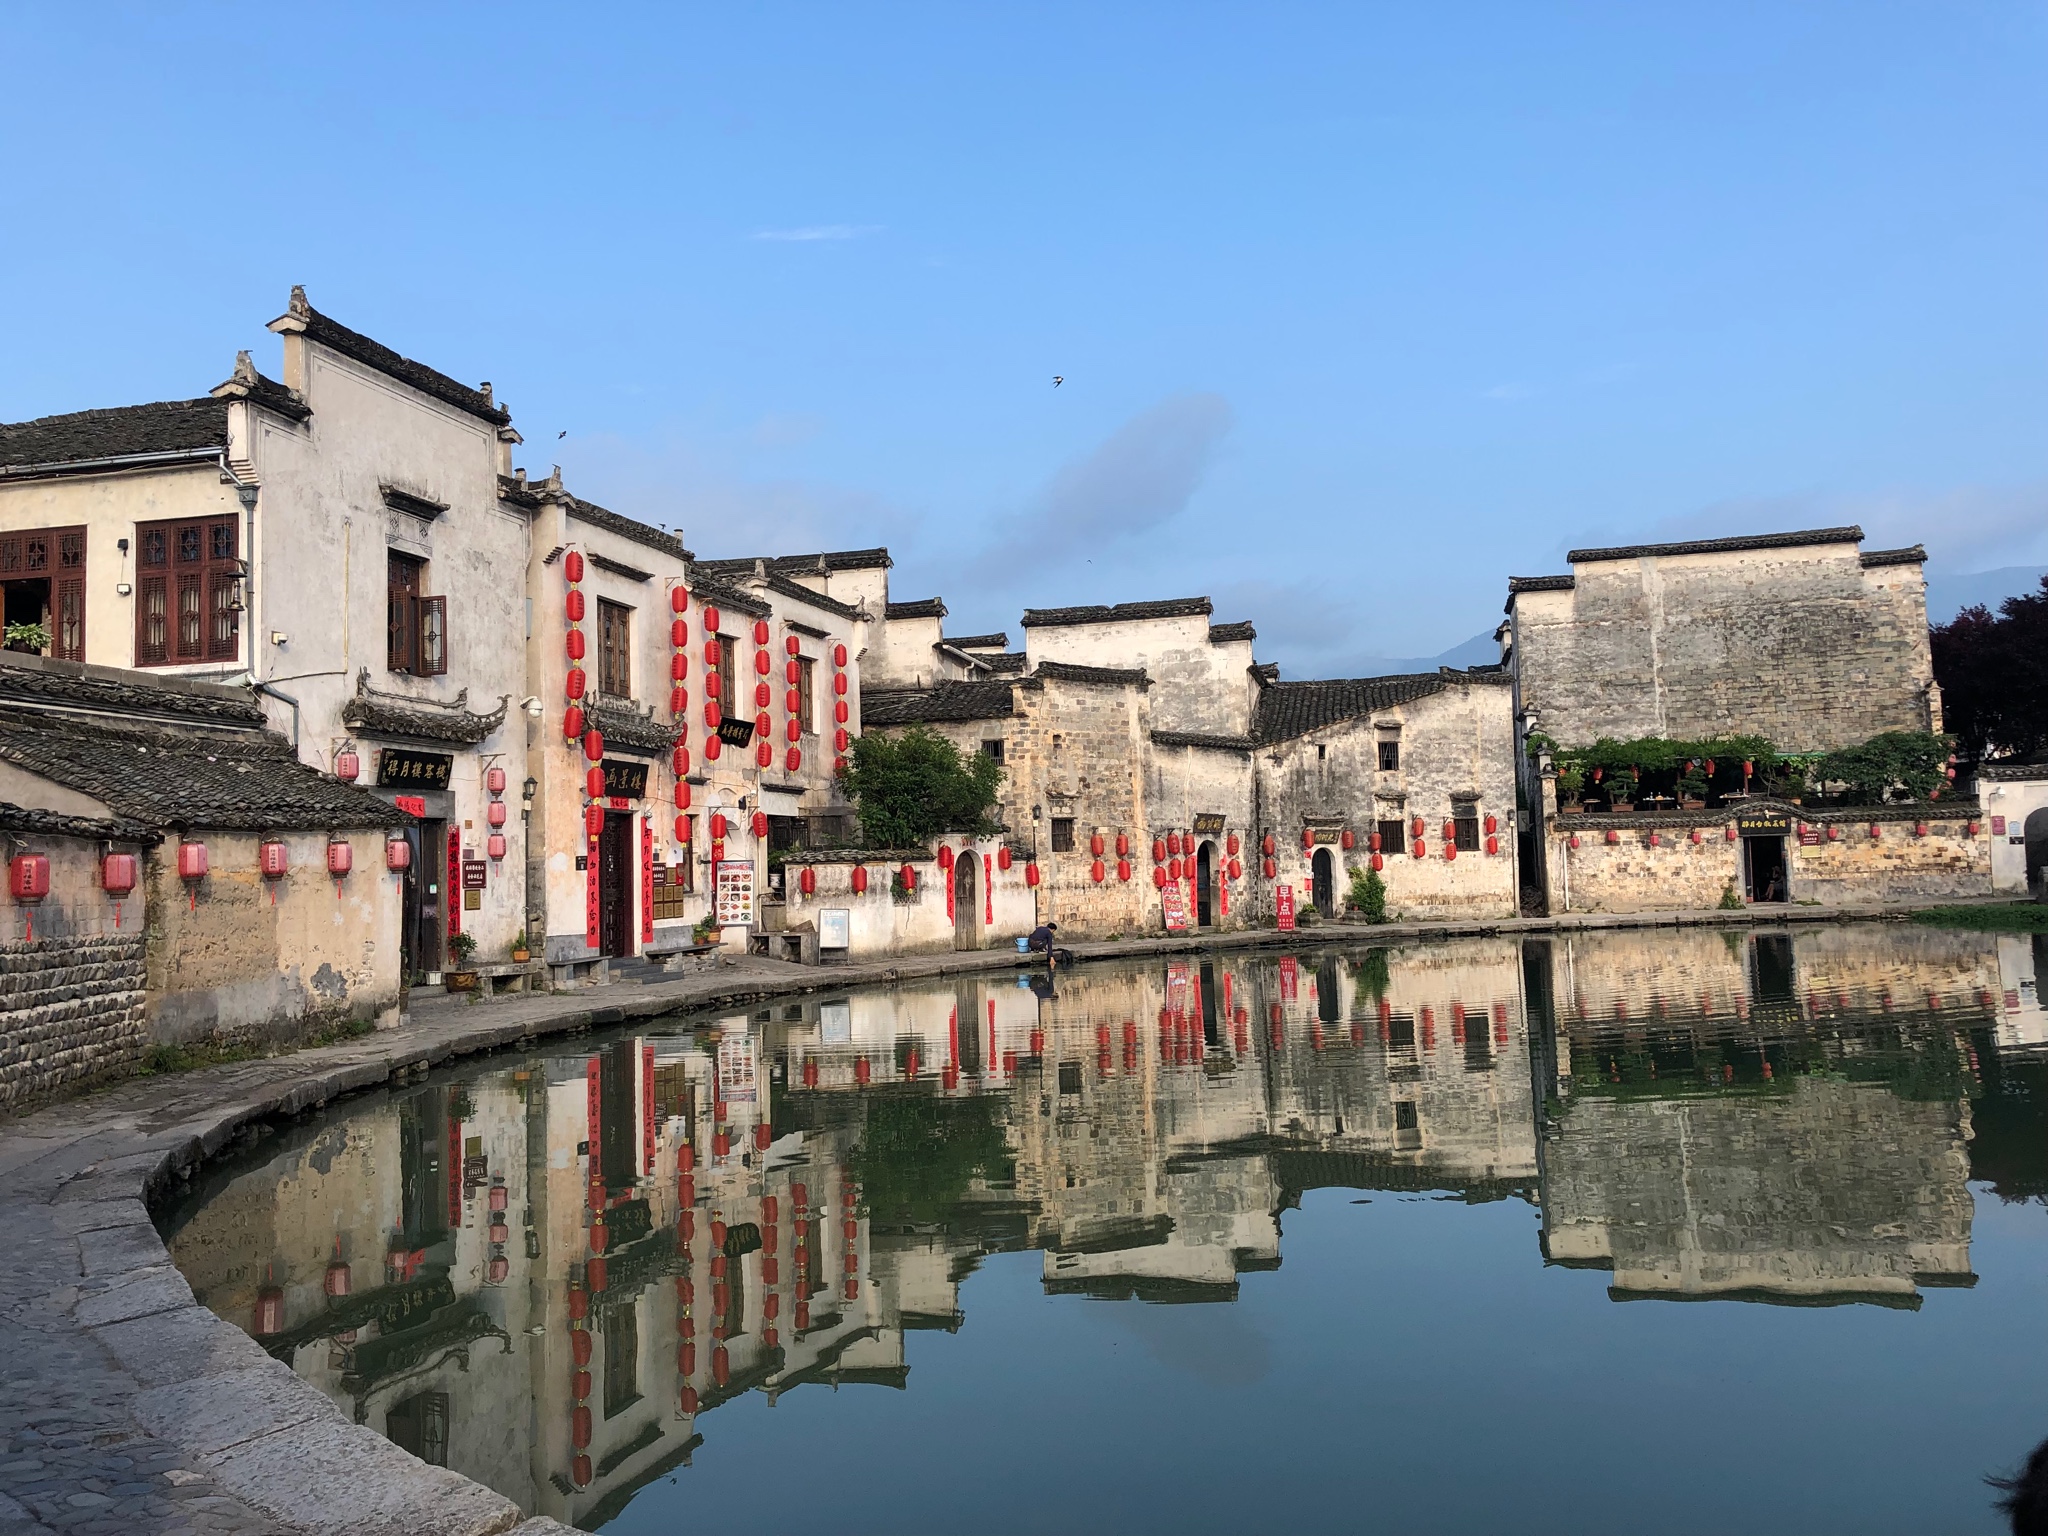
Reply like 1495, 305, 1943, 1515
0, 0, 2048, 676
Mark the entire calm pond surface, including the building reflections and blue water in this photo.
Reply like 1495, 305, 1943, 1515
166, 926, 2048, 1536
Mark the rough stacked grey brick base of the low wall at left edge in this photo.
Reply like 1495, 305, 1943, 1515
0, 932, 150, 1106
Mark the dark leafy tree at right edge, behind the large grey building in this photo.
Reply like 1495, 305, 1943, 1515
1931, 575, 2048, 760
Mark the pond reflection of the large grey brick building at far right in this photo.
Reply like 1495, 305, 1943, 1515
1532, 930, 1991, 1305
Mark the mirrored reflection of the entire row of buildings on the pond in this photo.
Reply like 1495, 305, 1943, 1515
172, 930, 2038, 1526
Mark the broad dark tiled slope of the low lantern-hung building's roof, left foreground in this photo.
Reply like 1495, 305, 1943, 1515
0, 705, 410, 831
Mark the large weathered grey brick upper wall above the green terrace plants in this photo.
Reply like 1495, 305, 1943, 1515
1513, 543, 1939, 752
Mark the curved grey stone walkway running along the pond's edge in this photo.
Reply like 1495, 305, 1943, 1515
0, 907, 1957, 1536
